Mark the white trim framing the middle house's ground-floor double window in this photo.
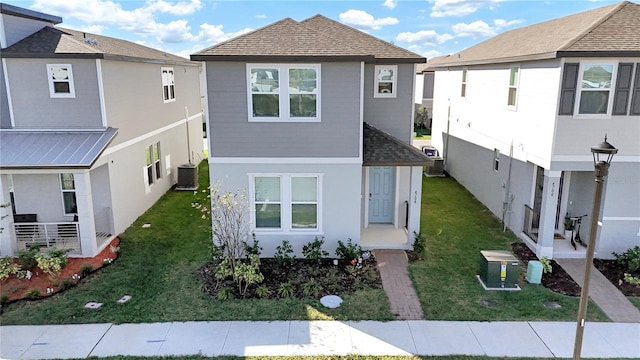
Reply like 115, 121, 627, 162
247, 173, 324, 235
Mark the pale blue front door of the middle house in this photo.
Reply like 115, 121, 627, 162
369, 166, 395, 223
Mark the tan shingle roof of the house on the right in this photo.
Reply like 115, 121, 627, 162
430, 1, 640, 67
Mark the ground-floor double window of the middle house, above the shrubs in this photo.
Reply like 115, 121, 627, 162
250, 174, 322, 232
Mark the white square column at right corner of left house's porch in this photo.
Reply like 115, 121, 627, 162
73, 171, 98, 257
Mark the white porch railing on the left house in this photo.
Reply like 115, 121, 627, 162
13, 222, 82, 255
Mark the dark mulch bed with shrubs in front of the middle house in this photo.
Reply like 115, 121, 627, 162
199, 255, 382, 299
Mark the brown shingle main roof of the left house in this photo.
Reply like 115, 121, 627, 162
2, 26, 187, 62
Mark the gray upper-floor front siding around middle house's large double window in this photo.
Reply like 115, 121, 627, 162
206, 62, 360, 157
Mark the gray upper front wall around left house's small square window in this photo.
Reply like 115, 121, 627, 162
7, 59, 102, 129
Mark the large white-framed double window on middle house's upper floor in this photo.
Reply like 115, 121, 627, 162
247, 64, 320, 122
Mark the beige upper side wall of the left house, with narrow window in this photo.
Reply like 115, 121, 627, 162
101, 60, 202, 145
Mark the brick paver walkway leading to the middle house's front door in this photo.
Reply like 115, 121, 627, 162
374, 250, 424, 320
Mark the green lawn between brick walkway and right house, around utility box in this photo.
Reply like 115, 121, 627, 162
409, 178, 608, 321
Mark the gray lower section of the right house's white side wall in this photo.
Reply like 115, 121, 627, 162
442, 136, 534, 238
